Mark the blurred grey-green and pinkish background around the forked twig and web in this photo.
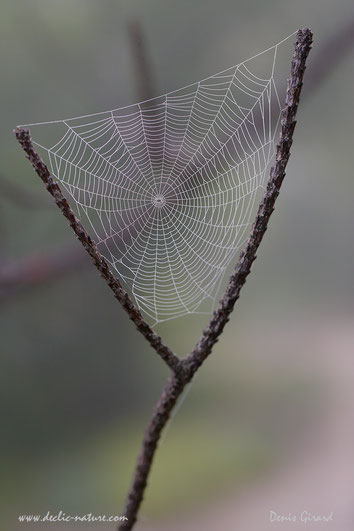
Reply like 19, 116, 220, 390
0, 0, 354, 531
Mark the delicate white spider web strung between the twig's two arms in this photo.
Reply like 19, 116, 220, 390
22, 37, 289, 324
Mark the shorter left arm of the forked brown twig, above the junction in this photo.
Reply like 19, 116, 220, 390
15, 127, 181, 374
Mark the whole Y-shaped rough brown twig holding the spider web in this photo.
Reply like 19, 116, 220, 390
15, 28, 312, 531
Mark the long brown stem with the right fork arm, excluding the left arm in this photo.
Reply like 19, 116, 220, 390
119, 29, 312, 531
